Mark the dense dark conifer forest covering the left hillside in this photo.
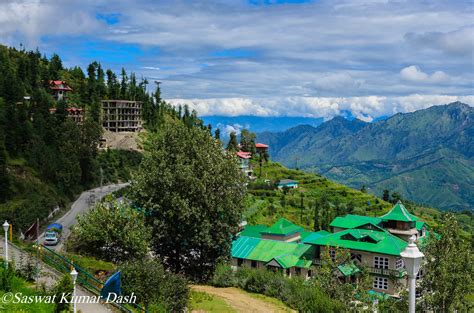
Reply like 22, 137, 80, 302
0, 45, 205, 231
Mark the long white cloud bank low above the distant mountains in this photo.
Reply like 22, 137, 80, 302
167, 94, 474, 120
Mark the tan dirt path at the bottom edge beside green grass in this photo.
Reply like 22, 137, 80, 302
191, 285, 296, 313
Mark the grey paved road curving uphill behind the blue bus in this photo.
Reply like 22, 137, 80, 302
39, 183, 129, 251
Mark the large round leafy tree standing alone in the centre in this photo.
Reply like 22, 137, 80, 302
131, 123, 245, 280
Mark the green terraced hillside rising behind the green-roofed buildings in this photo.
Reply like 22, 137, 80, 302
244, 162, 474, 237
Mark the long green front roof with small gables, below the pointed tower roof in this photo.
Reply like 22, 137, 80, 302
306, 229, 408, 255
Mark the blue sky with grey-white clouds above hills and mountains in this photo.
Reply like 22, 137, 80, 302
0, 0, 474, 121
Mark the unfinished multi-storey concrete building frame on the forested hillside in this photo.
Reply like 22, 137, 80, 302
102, 100, 142, 132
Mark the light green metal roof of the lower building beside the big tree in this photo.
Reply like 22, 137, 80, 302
232, 236, 315, 268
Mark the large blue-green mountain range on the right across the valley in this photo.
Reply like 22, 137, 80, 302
257, 102, 474, 210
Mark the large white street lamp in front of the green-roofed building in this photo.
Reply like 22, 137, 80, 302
400, 235, 425, 313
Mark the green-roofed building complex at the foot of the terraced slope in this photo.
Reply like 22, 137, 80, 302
232, 202, 430, 297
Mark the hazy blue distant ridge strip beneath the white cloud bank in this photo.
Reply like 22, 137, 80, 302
201, 115, 324, 133
